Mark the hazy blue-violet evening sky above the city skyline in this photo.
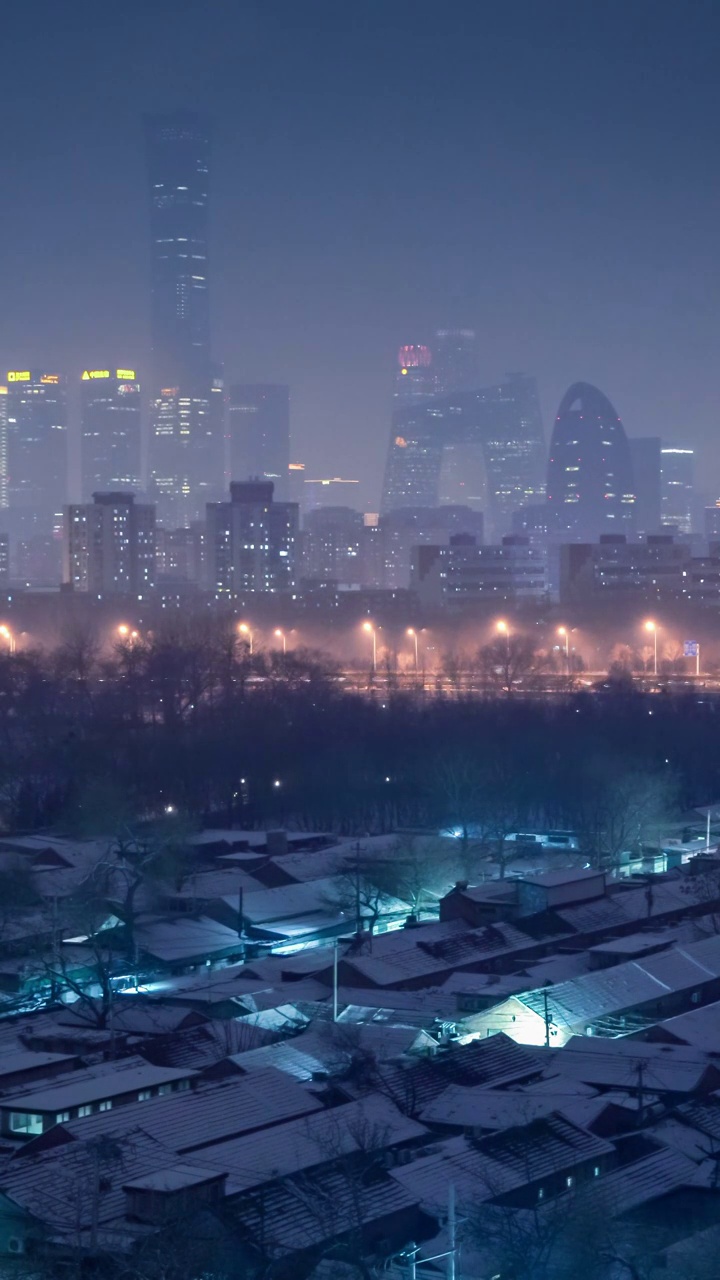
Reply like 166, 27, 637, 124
0, 0, 720, 504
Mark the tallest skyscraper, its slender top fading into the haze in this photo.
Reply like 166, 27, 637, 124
145, 111, 217, 526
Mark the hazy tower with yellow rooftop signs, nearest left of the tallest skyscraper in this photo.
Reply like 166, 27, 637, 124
81, 365, 140, 498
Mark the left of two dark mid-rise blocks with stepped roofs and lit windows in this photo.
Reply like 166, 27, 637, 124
64, 492, 155, 598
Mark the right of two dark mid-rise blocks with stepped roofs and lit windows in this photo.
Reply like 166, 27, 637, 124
206, 480, 300, 595
